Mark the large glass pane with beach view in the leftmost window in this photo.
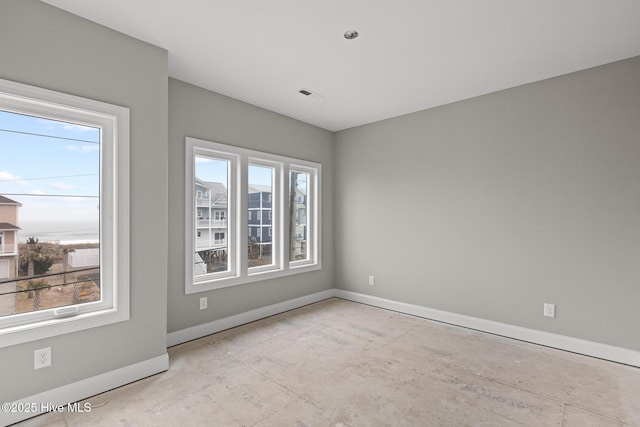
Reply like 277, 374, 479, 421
0, 110, 101, 316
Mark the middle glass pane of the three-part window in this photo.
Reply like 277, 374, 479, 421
247, 164, 274, 267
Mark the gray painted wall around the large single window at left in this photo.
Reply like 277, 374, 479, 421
0, 0, 167, 401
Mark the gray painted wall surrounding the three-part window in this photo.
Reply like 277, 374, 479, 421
168, 79, 334, 332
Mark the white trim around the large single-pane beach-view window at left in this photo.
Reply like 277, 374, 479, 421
0, 79, 129, 347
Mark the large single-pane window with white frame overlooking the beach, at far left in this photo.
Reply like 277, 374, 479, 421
0, 80, 129, 346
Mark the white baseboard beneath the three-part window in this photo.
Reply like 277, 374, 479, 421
167, 289, 335, 347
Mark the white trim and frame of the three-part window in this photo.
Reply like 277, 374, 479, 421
185, 137, 322, 294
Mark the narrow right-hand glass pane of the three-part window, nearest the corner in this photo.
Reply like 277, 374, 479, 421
289, 170, 309, 261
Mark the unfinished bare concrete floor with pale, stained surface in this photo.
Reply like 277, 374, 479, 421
15, 299, 640, 427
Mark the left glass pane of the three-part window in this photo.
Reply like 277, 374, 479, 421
193, 156, 229, 276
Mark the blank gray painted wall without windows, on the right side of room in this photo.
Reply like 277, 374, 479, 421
335, 58, 640, 350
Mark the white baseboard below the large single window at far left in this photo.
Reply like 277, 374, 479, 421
0, 353, 169, 425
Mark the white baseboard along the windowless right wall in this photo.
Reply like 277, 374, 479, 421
334, 289, 640, 367
